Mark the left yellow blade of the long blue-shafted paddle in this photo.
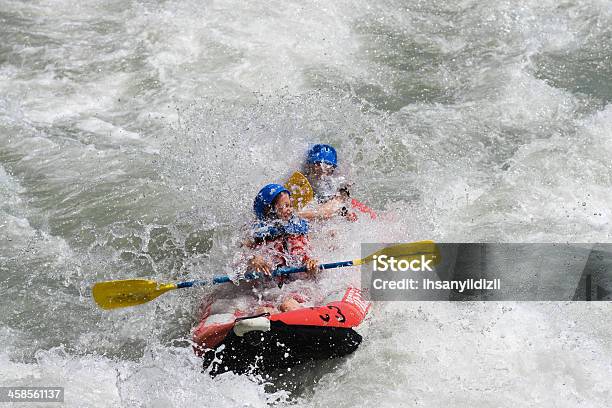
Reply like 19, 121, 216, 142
92, 279, 176, 309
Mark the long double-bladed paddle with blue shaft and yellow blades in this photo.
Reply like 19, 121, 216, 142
92, 241, 440, 309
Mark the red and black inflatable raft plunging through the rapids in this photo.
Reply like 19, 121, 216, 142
193, 287, 370, 376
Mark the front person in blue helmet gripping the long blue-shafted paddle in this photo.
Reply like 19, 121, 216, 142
247, 184, 319, 311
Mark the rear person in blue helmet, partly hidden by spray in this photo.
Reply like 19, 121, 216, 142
300, 143, 357, 221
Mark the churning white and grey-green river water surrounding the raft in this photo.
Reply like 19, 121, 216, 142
0, 0, 612, 407
